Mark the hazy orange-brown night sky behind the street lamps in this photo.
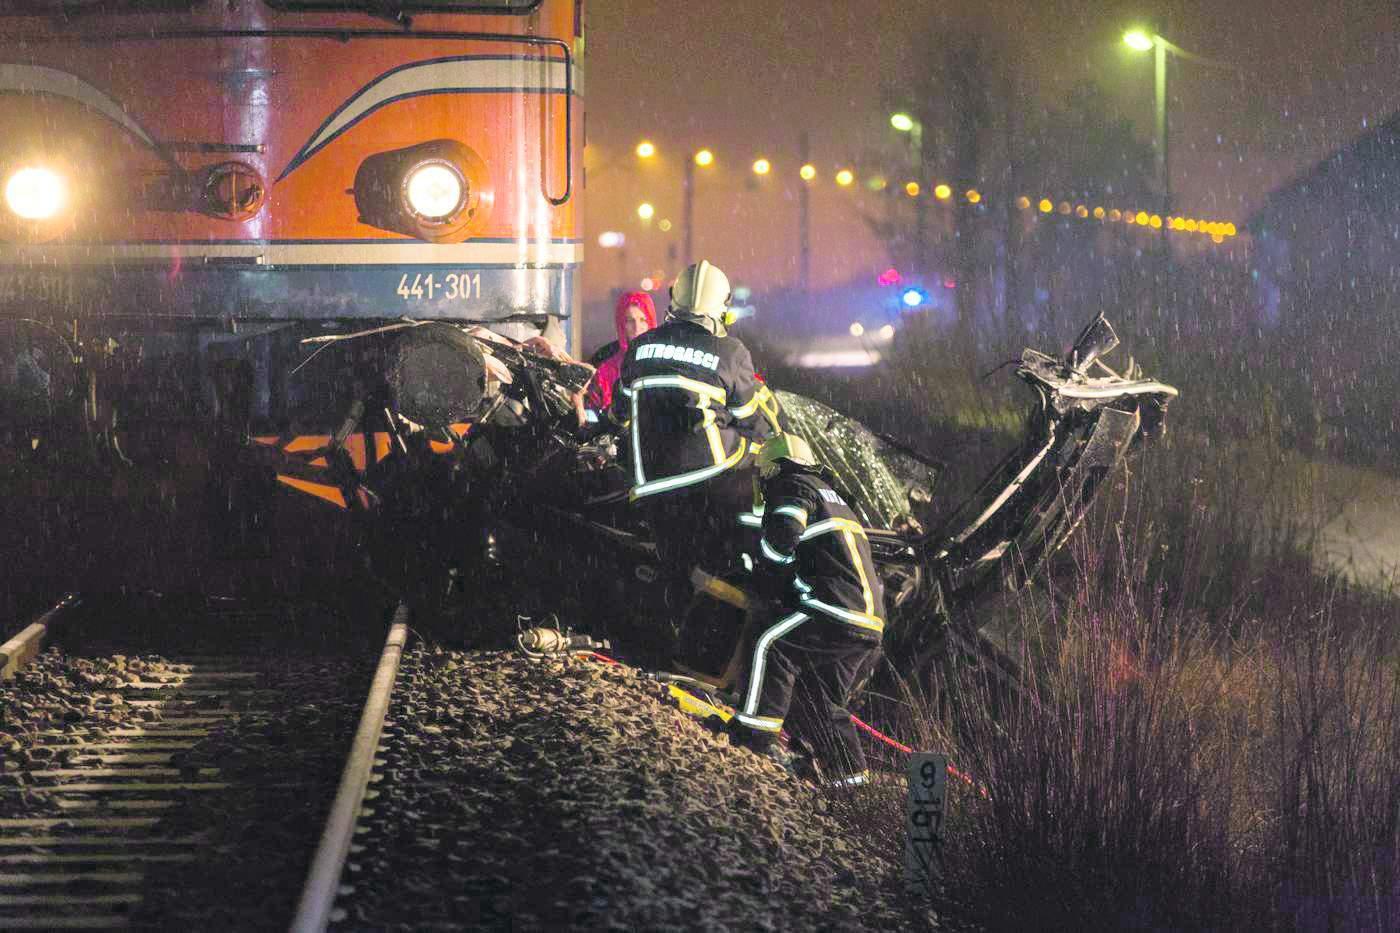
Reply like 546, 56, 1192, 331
585, 0, 1400, 298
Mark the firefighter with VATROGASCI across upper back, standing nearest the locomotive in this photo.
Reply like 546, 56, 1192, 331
610, 259, 771, 574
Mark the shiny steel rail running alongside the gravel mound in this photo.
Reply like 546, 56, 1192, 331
290, 602, 409, 933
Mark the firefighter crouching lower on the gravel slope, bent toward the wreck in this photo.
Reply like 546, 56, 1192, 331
731, 434, 885, 786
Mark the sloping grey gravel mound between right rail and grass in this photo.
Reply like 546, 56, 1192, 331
335, 647, 944, 930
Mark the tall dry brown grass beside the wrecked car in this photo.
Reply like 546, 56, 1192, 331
812, 337, 1400, 930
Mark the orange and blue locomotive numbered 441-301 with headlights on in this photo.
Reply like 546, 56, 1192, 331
0, 0, 584, 588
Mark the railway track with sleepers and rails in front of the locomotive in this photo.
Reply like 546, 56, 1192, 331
0, 591, 407, 930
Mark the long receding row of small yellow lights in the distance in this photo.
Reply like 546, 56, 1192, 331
624, 140, 1238, 244
